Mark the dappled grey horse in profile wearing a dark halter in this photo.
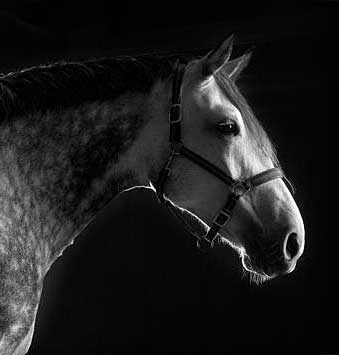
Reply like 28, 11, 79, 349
0, 36, 305, 355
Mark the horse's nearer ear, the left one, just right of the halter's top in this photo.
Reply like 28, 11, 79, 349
202, 34, 234, 76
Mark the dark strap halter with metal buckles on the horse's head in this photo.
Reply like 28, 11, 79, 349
156, 62, 289, 248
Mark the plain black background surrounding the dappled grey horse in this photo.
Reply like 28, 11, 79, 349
0, 0, 339, 355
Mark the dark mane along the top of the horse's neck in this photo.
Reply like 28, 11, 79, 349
0, 55, 186, 122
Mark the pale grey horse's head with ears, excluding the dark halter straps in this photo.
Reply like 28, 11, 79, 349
161, 36, 304, 279
